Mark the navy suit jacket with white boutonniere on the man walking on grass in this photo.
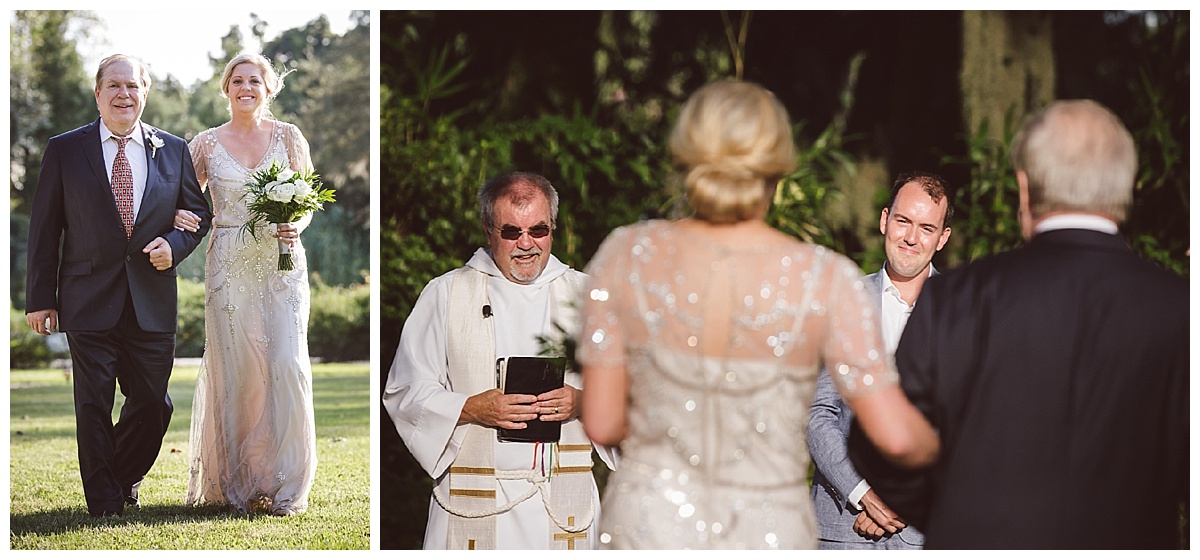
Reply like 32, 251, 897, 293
25, 119, 212, 332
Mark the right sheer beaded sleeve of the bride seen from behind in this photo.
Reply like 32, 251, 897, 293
823, 253, 899, 398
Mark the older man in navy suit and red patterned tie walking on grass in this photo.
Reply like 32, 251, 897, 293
25, 55, 211, 517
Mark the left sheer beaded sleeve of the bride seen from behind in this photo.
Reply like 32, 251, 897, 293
576, 227, 634, 366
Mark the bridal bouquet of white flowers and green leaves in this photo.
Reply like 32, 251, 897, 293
241, 159, 334, 270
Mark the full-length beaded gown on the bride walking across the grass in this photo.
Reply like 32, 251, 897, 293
187, 122, 317, 516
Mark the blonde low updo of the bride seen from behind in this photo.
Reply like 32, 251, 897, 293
670, 82, 796, 223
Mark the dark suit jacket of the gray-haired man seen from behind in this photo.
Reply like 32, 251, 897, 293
850, 229, 1189, 549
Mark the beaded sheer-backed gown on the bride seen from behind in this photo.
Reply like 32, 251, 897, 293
577, 221, 896, 549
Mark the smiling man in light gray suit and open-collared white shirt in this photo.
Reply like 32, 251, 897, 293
808, 173, 954, 549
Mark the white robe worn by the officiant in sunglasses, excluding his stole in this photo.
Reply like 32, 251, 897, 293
383, 248, 616, 549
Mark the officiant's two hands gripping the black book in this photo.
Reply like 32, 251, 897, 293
458, 385, 580, 429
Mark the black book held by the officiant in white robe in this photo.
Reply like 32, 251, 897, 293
496, 356, 566, 442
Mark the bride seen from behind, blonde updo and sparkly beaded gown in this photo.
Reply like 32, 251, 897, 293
577, 82, 936, 549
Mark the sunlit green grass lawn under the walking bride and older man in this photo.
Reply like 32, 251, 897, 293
8, 363, 372, 549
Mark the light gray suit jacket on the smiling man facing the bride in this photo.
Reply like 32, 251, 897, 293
808, 269, 921, 548
